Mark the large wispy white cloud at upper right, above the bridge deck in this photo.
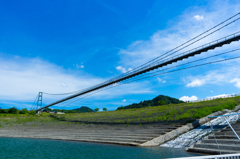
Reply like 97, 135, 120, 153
119, 1, 240, 68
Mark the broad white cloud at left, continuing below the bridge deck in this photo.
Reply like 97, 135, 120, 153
0, 58, 152, 107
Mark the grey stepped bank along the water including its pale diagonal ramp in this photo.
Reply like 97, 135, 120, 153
0, 106, 240, 146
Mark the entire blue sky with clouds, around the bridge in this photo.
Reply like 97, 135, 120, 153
0, 0, 240, 110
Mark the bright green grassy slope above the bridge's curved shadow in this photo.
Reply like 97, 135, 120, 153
54, 97, 240, 124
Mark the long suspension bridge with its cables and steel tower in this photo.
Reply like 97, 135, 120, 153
32, 12, 240, 112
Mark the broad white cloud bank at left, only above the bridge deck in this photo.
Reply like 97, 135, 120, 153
0, 58, 103, 101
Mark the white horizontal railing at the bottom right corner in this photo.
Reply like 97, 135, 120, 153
169, 153, 240, 159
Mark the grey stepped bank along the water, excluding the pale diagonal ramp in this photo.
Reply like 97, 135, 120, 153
0, 124, 181, 146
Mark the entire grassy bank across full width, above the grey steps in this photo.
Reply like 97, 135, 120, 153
0, 97, 240, 128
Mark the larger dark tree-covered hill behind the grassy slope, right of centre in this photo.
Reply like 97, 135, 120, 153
117, 95, 184, 110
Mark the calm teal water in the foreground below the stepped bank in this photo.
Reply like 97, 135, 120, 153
0, 138, 202, 159
